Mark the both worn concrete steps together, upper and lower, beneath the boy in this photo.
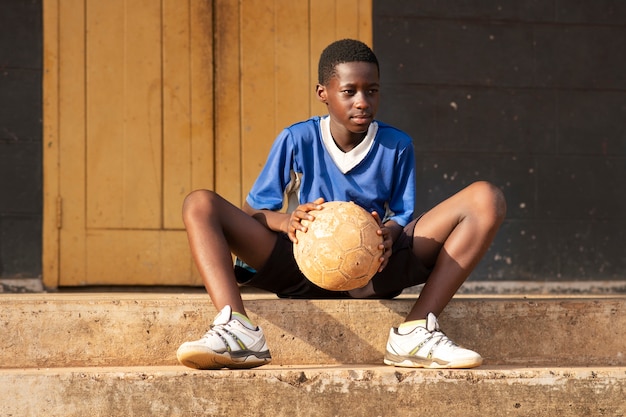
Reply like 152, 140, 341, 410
0, 293, 626, 417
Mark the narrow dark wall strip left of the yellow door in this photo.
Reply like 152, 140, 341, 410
0, 0, 42, 278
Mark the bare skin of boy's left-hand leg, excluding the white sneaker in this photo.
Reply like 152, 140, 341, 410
183, 190, 277, 315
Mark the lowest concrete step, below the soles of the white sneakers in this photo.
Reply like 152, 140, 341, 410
0, 365, 626, 417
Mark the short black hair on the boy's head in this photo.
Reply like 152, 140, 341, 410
317, 39, 380, 85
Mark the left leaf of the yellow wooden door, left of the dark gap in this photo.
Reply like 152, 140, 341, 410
44, 0, 214, 286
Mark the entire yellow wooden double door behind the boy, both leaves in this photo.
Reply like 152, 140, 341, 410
43, 0, 371, 287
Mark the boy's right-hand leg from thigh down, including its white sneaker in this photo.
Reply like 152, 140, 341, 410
384, 182, 506, 368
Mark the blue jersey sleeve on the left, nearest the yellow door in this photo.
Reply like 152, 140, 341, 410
246, 129, 294, 211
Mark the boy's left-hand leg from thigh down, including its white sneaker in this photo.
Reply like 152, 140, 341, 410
176, 190, 277, 369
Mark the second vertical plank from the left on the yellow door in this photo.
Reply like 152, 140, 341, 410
84, 0, 125, 228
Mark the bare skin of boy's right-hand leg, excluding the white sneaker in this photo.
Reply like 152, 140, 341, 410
406, 182, 506, 321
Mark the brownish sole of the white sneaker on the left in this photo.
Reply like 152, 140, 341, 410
177, 351, 272, 370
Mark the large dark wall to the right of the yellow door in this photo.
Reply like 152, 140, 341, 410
374, 0, 626, 281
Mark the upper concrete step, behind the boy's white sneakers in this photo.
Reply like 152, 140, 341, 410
0, 293, 626, 369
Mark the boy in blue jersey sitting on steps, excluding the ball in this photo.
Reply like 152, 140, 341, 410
177, 39, 506, 369
